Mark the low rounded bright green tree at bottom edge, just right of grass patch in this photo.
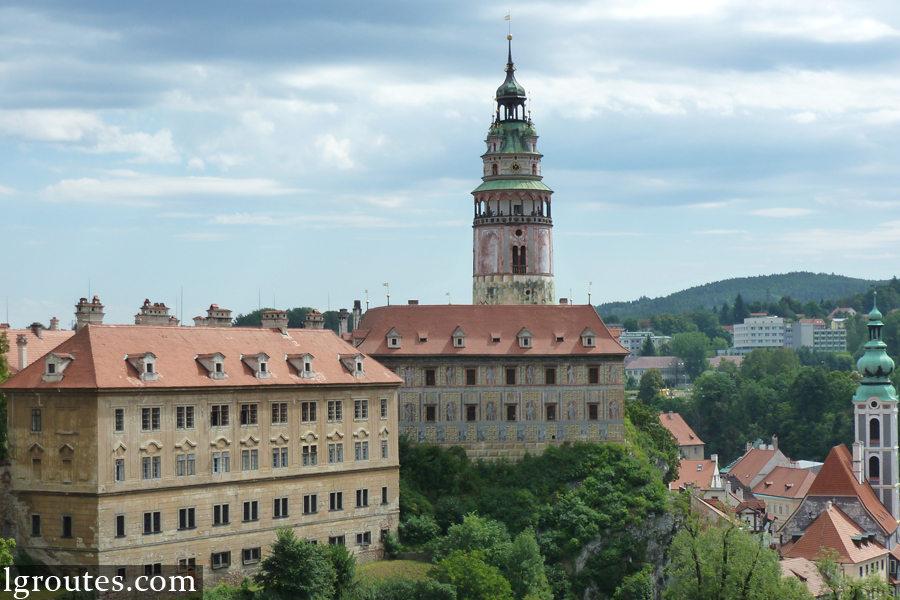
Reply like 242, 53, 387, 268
428, 552, 513, 600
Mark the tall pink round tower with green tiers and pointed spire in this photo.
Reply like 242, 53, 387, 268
472, 35, 556, 304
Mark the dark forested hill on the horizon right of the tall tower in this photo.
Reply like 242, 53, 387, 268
597, 271, 886, 319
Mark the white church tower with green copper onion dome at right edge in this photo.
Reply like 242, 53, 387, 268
853, 297, 900, 521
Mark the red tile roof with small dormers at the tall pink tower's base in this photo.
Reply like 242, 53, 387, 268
359, 304, 629, 357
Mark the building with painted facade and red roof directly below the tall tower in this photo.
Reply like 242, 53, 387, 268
353, 304, 628, 459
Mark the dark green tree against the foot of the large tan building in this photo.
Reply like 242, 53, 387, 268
253, 527, 336, 600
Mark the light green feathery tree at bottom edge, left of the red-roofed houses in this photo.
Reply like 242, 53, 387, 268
664, 519, 812, 600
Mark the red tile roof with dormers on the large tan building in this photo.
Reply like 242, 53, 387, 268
0, 325, 401, 389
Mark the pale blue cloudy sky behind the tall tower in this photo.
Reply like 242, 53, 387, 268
0, 0, 900, 327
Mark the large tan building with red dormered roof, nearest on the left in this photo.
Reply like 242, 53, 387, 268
0, 319, 401, 580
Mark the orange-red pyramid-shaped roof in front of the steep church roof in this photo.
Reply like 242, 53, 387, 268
781, 505, 888, 564
